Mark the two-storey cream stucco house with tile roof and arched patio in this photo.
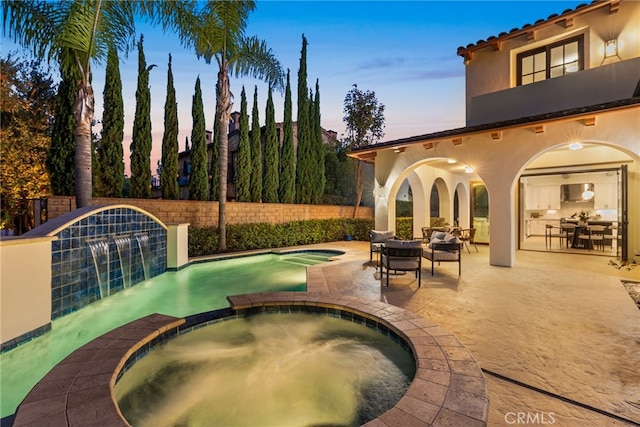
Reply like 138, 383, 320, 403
351, 0, 640, 267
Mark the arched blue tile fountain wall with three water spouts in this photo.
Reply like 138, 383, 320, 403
51, 207, 167, 320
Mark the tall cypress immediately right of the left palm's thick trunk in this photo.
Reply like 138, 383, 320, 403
93, 46, 124, 197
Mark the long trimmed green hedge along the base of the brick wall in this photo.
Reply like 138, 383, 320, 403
189, 219, 373, 257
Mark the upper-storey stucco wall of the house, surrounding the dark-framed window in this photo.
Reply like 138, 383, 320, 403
465, 1, 640, 126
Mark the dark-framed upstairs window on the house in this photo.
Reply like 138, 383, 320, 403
516, 35, 584, 86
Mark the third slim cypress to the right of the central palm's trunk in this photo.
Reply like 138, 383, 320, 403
262, 86, 280, 203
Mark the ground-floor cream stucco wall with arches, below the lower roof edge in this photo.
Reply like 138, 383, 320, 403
374, 104, 640, 266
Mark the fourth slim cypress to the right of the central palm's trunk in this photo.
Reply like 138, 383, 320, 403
280, 70, 296, 203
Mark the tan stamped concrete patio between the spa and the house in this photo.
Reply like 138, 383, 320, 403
307, 242, 640, 427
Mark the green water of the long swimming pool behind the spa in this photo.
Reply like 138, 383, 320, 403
0, 251, 337, 418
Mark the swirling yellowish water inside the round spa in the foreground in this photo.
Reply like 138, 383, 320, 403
114, 313, 415, 427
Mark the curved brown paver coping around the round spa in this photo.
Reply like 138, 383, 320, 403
13, 292, 489, 427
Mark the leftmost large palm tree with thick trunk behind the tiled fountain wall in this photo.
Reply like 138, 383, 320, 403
2, 0, 136, 207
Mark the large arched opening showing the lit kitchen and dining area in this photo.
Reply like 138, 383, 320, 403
518, 142, 636, 257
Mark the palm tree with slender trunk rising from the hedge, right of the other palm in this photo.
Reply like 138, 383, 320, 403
179, 0, 284, 251
